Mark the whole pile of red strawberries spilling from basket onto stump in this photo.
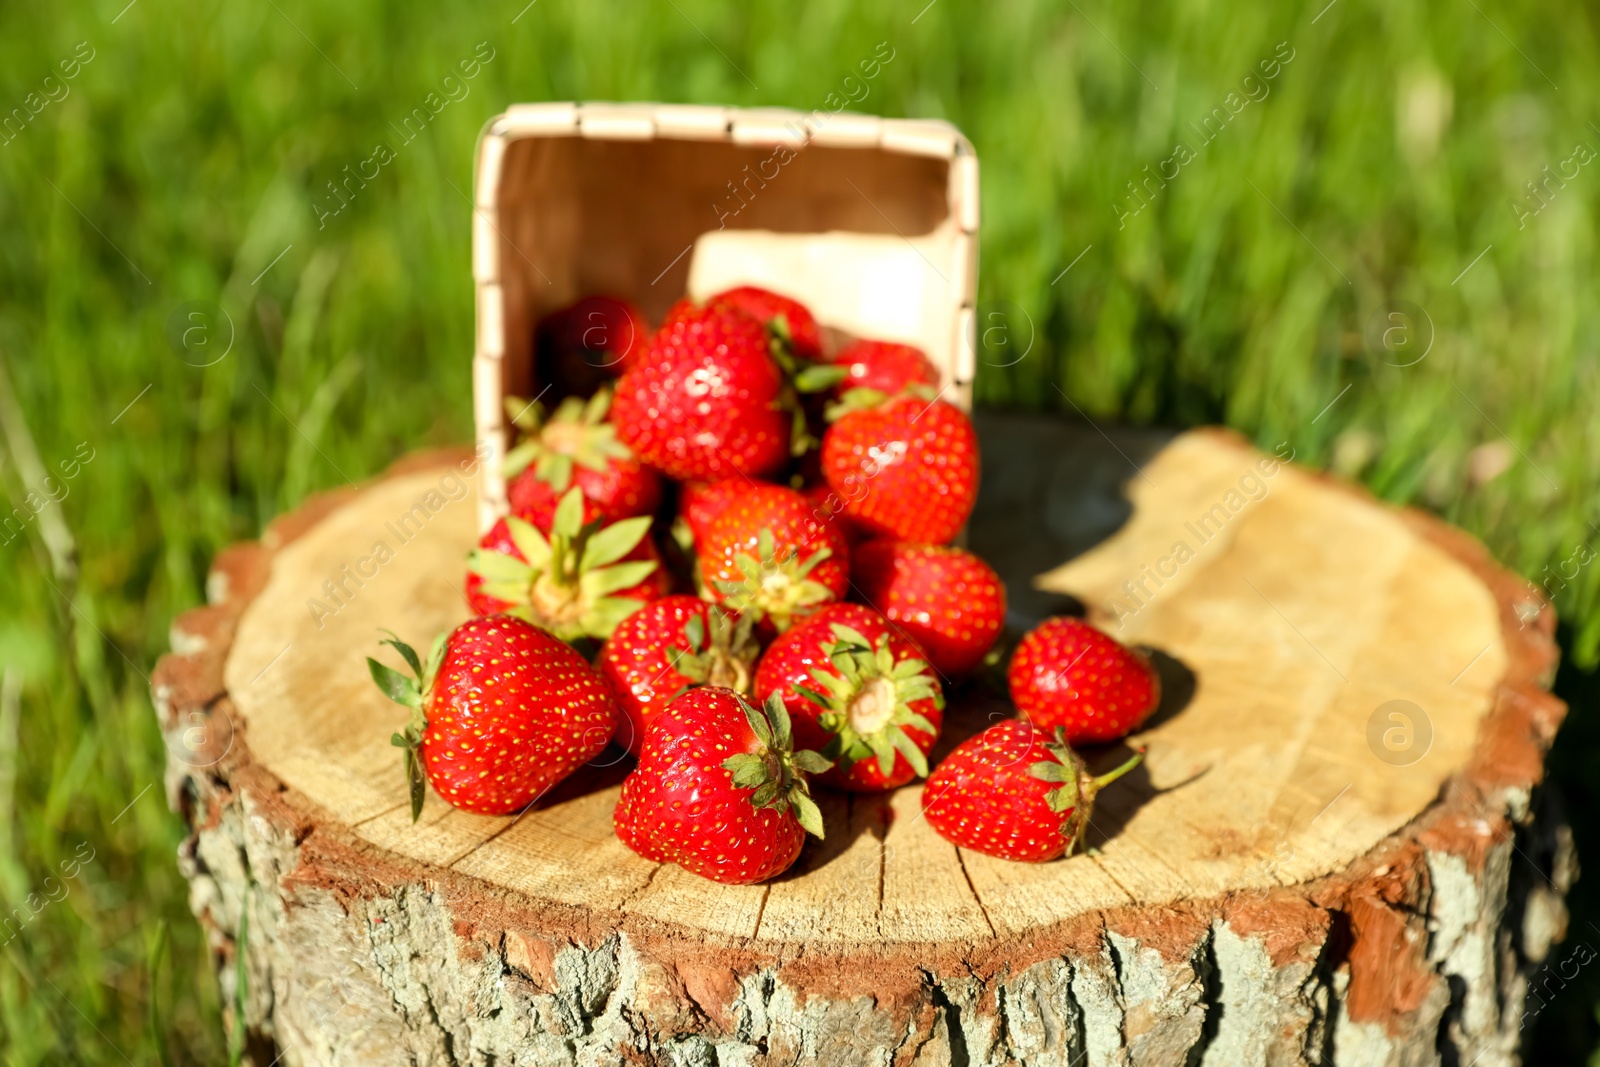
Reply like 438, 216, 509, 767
368, 288, 1158, 883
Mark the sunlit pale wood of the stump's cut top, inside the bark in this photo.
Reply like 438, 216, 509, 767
226, 434, 1506, 944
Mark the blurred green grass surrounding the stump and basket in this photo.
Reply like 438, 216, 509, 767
0, 0, 1600, 1064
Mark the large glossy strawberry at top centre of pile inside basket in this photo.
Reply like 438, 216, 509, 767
611, 306, 792, 482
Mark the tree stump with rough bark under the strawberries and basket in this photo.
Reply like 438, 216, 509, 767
154, 416, 1573, 1067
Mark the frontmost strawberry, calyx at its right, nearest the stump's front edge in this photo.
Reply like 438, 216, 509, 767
613, 686, 827, 885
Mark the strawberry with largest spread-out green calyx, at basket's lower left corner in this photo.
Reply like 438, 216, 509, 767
467, 486, 669, 641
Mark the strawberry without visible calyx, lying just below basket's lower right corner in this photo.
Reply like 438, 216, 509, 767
850, 541, 1005, 678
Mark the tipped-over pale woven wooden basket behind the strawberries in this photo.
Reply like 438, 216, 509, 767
472, 104, 978, 530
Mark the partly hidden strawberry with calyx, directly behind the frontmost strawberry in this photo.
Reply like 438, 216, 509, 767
595, 597, 760, 755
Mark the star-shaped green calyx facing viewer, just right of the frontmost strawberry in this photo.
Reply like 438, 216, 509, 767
795, 622, 944, 777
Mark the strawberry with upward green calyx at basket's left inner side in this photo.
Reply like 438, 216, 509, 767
506, 389, 661, 533
